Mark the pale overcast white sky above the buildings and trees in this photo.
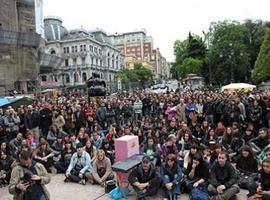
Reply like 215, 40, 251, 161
43, 0, 270, 61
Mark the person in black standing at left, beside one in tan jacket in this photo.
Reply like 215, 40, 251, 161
39, 104, 53, 137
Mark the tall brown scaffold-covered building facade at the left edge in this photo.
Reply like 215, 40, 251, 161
0, 0, 41, 95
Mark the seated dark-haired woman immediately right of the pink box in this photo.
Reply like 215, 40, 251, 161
141, 136, 161, 166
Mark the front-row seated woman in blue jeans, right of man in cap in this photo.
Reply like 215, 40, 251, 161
160, 154, 183, 200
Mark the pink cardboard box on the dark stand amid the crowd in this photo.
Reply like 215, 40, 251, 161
114, 135, 140, 162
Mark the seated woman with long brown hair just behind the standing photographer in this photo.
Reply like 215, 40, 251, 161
33, 137, 57, 174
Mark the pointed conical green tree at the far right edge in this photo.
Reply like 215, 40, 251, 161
252, 28, 270, 84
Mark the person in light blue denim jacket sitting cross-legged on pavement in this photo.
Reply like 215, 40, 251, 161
65, 143, 93, 185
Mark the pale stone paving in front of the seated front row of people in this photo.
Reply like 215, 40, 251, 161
0, 174, 249, 200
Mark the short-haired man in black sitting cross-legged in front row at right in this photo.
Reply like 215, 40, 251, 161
208, 151, 240, 200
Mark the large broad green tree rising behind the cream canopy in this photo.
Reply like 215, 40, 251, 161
209, 21, 250, 84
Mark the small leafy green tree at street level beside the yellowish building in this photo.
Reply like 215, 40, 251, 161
118, 63, 154, 85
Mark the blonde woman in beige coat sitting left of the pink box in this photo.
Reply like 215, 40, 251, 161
92, 149, 114, 185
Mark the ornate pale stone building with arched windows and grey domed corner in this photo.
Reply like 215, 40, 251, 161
43, 17, 123, 90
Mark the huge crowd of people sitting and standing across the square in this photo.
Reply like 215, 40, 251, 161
0, 90, 270, 200
